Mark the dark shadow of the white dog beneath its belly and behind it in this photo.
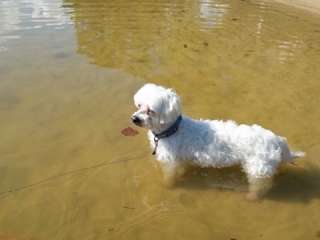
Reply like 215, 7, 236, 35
175, 165, 320, 202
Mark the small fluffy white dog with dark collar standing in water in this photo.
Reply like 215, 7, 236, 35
131, 84, 304, 199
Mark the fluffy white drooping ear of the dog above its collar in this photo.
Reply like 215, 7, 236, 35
160, 89, 181, 124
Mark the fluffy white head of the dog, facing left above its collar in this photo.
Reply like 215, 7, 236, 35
131, 83, 181, 133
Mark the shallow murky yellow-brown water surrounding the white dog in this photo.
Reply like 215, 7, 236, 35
0, 0, 320, 240
